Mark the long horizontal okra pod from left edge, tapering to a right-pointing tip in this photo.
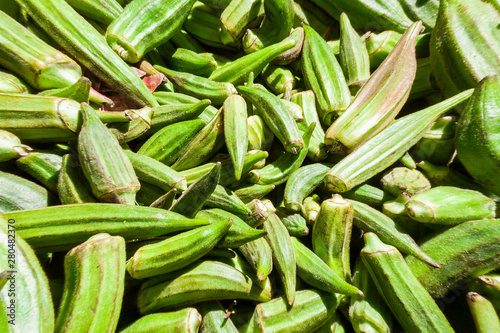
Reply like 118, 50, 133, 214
5, 203, 210, 252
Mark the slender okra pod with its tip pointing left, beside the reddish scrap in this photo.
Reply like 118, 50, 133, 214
155, 65, 236, 105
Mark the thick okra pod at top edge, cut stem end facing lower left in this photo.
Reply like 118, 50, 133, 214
106, 0, 195, 63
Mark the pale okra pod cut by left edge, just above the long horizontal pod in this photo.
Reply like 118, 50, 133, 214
0, 171, 57, 212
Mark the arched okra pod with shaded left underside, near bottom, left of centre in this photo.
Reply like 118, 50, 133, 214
137, 260, 271, 314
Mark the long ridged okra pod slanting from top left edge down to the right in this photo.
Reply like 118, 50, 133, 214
19, 0, 158, 106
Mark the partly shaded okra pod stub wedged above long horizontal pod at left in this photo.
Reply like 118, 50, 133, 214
57, 154, 97, 205
